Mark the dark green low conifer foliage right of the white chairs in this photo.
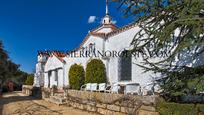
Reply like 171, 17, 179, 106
161, 65, 204, 101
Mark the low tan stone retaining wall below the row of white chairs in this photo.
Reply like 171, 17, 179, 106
67, 90, 159, 115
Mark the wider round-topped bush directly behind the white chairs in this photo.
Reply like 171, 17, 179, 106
85, 59, 106, 83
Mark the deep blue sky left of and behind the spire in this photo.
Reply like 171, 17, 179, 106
0, 0, 133, 73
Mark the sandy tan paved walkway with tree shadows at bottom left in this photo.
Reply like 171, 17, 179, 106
0, 92, 93, 115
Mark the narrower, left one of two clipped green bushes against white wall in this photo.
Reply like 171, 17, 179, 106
69, 64, 85, 90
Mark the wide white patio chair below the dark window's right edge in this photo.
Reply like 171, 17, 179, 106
125, 83, 141, 95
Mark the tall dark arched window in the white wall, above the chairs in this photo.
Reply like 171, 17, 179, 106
118, 50, 132, 81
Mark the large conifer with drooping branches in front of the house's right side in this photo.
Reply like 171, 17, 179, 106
114, 0, 204, 98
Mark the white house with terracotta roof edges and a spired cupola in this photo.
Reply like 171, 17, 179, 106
34, 0, 159, 88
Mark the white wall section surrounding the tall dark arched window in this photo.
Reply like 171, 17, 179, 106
105, 26, 161, 86
